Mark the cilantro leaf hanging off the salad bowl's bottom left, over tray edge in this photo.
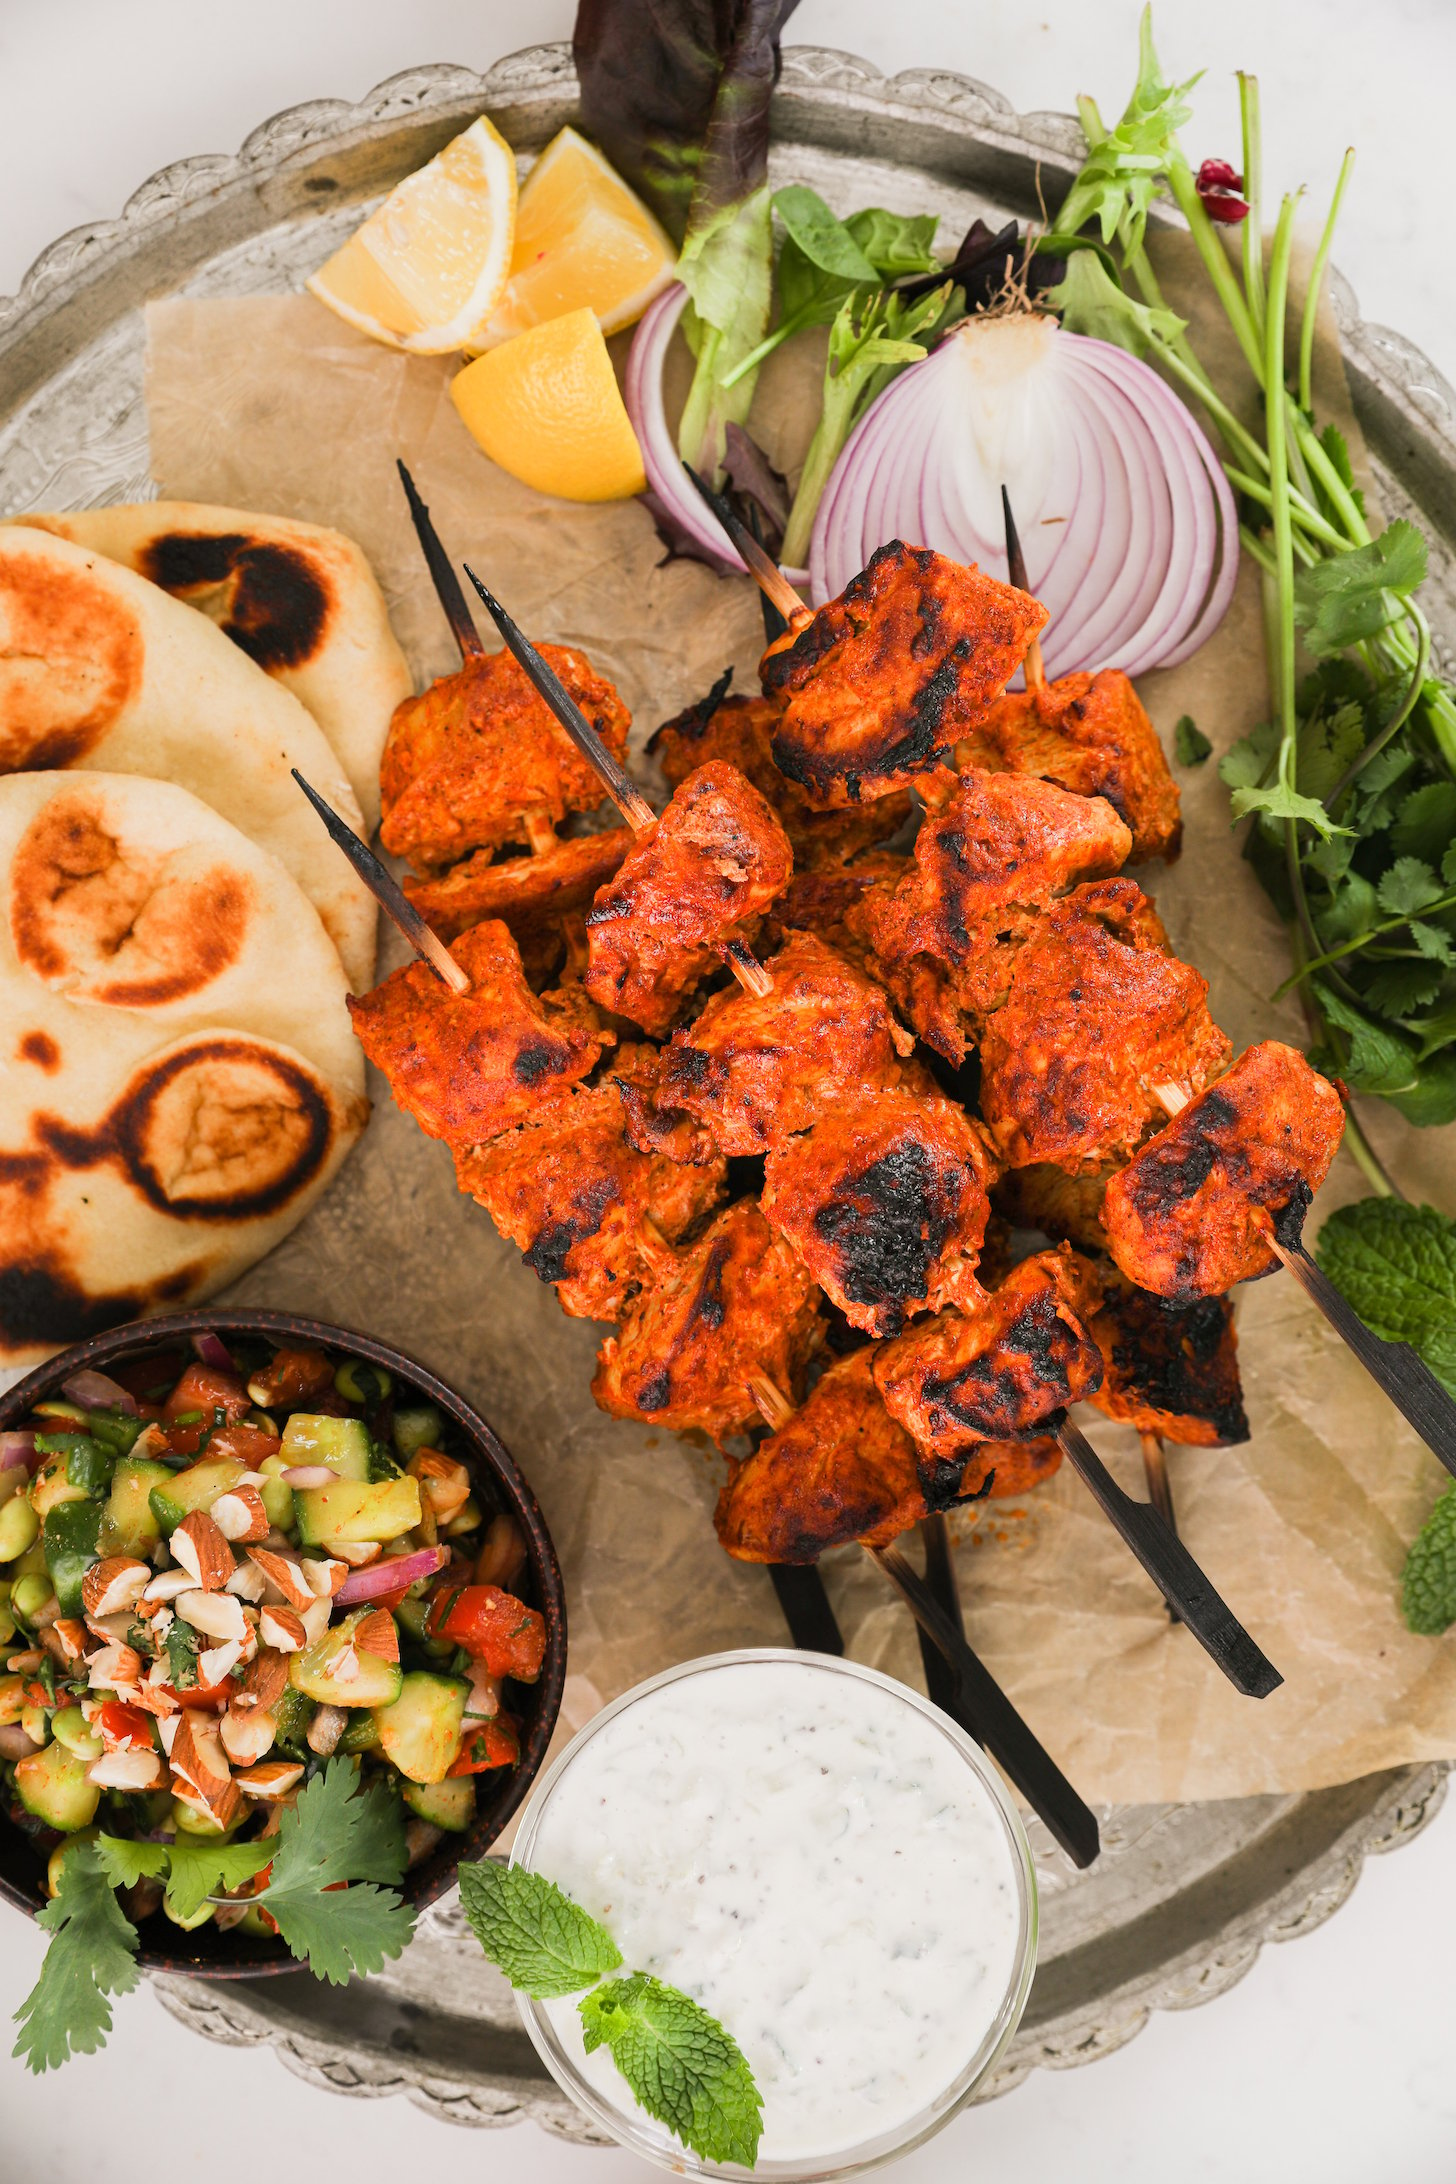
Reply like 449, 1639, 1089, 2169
11, 1843, 138, 2073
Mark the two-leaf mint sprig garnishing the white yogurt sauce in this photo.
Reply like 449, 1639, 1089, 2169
461, 1861, 764, 2169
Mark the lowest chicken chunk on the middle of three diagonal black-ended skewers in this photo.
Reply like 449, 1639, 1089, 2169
875, 1249, 1102, 1457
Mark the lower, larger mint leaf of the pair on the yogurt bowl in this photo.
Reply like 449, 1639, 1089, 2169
576, 1972, 764, 2169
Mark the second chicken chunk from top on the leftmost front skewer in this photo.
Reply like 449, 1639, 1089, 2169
454, 1052, 727, 1319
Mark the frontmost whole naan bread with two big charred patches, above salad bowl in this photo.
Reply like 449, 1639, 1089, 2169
0, 773, 369, 1365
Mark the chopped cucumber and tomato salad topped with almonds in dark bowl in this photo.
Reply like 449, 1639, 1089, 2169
0, 1334, 546, 1968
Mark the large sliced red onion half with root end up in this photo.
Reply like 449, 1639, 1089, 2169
810, 314, 1238, 675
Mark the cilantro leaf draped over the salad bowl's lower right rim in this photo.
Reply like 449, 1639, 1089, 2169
260, 1758, 415, 1987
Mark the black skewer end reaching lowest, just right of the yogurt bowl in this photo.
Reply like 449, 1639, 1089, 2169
749, 1372, 1102, 1867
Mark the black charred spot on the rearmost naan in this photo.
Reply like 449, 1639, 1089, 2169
138, 531, 334, 675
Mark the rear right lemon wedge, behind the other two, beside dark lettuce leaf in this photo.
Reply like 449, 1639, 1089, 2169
469, 129, 677, 349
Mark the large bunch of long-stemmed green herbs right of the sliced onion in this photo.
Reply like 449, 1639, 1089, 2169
1041, 11, 1456, 1161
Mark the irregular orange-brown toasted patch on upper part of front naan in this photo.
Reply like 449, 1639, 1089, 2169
11, 791, 253, 1009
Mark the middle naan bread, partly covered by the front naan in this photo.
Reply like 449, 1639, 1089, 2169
0, 524, 375, 992
